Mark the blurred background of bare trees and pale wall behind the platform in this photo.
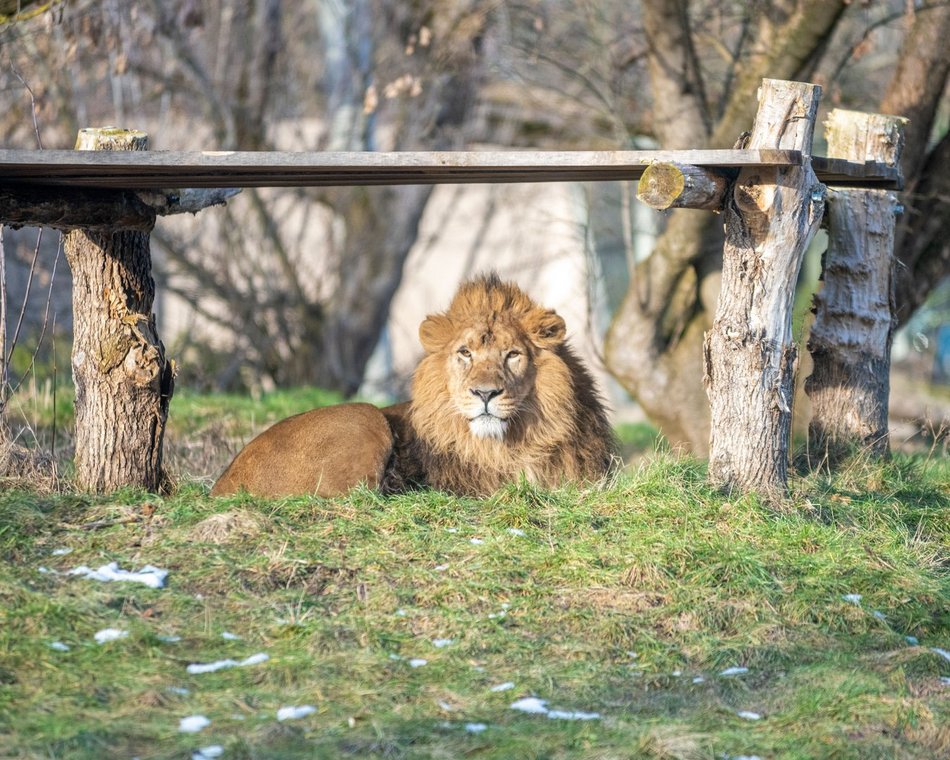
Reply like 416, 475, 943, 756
0, 0, 950, 478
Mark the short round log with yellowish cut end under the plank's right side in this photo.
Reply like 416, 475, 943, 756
637, 162, 729, 211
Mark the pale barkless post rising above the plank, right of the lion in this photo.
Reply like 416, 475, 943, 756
704, 79, 824, 497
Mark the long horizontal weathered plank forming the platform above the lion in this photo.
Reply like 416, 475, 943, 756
0, 150, 897, 189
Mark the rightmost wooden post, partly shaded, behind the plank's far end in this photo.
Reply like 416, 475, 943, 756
805, 109, 907, 466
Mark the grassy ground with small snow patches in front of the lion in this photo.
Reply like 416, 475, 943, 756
0, 388, 950, 760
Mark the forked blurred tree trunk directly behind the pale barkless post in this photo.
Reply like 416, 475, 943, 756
605, 0, 848, 456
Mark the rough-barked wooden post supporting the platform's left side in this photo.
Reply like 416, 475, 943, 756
65, 127, 175, 491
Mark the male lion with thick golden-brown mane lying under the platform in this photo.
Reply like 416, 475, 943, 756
211, 274, 616, 496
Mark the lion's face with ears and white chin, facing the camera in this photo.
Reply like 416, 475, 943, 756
416, 282, 565, 441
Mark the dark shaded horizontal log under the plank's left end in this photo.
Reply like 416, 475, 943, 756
0, 185, 240, 232
